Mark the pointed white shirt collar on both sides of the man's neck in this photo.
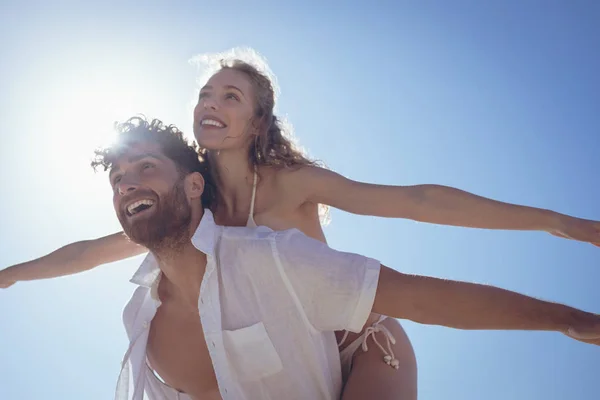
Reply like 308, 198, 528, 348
130, 209, 218, 288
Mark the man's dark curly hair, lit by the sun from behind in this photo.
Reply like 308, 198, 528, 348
91, 117, 216, 208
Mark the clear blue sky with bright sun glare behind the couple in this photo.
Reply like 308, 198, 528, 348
0, 0, 600, 400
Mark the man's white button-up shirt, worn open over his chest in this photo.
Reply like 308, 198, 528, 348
116, 210, 380, 400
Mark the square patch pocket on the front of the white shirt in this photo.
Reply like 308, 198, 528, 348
223, 322, 283, 381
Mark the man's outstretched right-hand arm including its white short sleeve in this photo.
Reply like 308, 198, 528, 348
276, 230, 600, 345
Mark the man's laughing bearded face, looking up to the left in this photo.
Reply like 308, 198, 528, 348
109, 143, 191, 250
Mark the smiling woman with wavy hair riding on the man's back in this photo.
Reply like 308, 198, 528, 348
0, 47, 600, 399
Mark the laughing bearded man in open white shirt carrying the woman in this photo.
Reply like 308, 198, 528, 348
105, 119, 600, 400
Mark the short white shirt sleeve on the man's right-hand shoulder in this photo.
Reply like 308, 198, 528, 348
275, 229, 381, 332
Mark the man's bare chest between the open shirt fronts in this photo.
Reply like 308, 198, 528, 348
147, 303, 220, 398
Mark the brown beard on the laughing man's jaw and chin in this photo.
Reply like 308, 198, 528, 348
118, 179, 192, 253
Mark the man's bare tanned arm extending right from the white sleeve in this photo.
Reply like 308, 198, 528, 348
373, 266, 600, 344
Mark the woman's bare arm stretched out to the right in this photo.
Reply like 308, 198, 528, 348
281, 167, 600, 246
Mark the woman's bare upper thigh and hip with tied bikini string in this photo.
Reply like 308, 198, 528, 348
342, 316, 417, 400
